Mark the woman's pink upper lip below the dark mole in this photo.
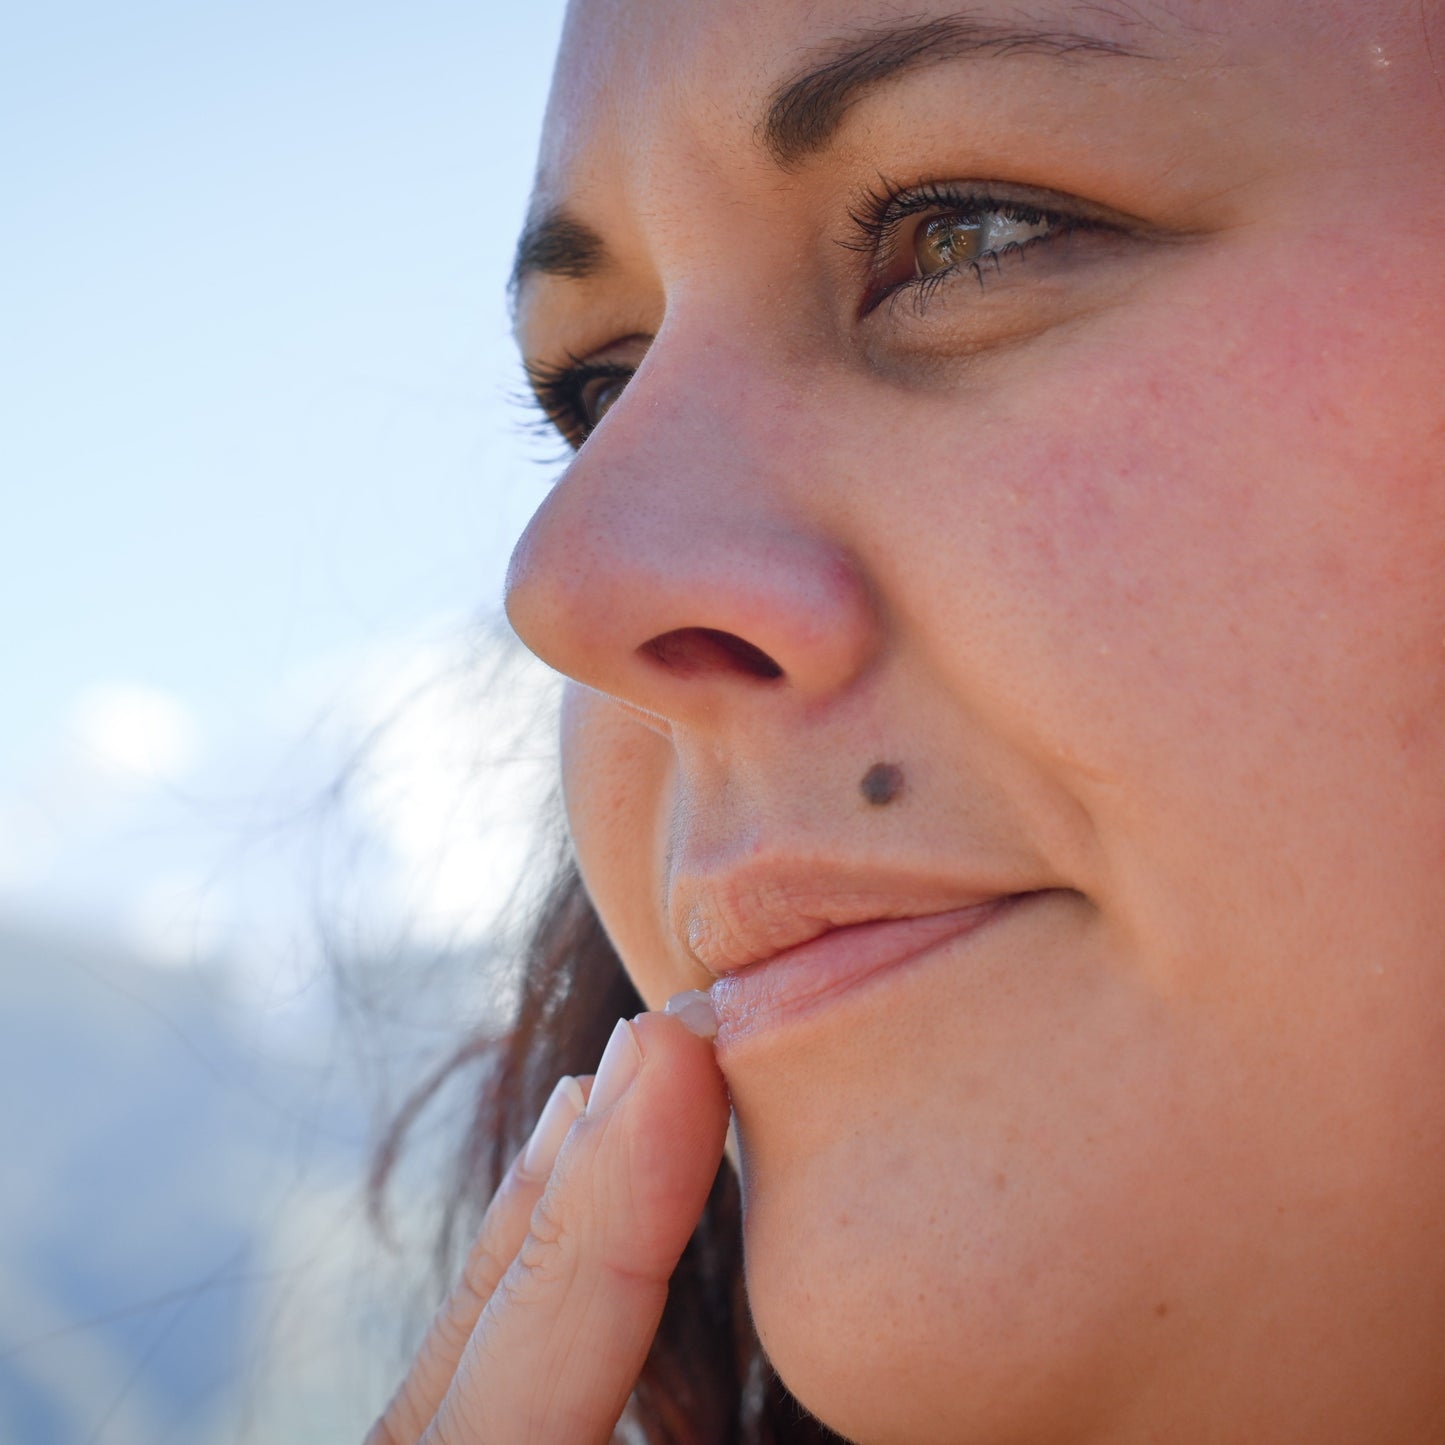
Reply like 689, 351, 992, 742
669, 860, 1033, 975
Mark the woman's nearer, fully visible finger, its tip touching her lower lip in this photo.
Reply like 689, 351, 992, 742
425, 1013, 728, 1445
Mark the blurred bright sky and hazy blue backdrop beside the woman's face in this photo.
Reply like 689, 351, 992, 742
0, 0, 575, 1445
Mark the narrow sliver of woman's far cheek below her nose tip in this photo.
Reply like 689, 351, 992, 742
562, 683, 691, 1007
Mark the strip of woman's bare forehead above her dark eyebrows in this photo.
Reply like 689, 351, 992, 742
538, 0, 1410, 189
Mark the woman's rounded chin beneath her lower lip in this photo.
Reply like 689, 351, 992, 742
731, 942, 1211, 1445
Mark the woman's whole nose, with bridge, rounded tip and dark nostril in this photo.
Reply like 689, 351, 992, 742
507, 337, 880, 724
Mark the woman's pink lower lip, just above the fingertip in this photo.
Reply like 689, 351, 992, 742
711, 893, 1033, 1048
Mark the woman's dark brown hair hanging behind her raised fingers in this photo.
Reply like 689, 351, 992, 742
370, 853, 838, 1445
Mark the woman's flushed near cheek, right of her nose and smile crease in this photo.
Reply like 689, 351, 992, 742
899, 284, 1445, 1016
